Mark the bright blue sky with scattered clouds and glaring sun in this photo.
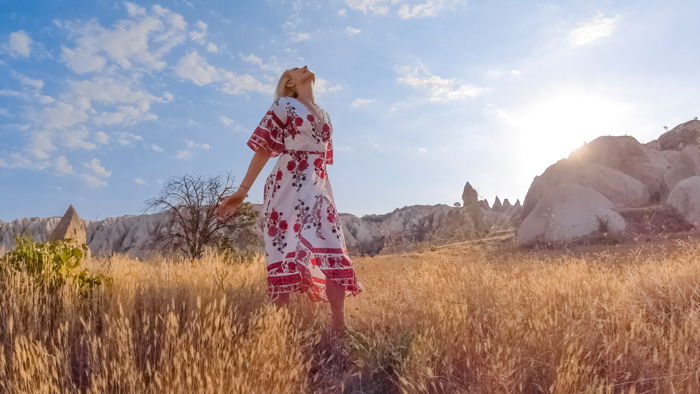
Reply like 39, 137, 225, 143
0, 0, 700, 221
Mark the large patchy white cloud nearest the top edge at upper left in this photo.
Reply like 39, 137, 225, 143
58, 3, 187, 73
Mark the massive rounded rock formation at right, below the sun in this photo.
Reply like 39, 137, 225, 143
516, 120, 700, 244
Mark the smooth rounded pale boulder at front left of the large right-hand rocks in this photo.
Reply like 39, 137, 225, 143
516, 183, 625, 245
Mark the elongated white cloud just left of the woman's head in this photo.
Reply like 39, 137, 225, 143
175, 51, 273, 95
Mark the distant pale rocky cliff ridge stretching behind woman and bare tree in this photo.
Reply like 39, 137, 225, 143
0, 183, 521, 256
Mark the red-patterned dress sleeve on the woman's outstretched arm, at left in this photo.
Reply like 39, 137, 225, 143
246, 97, 288, 157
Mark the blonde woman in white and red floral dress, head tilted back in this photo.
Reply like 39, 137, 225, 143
217, 66, 363, 333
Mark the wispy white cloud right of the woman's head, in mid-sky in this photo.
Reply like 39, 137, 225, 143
397, 64, 485, 102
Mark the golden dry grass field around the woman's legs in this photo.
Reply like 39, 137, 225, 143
0, 232, 700, 393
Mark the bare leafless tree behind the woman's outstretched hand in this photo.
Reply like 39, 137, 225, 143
145, 173, 258, 259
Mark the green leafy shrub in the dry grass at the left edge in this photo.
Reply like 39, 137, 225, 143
0, 237, 111, 297
